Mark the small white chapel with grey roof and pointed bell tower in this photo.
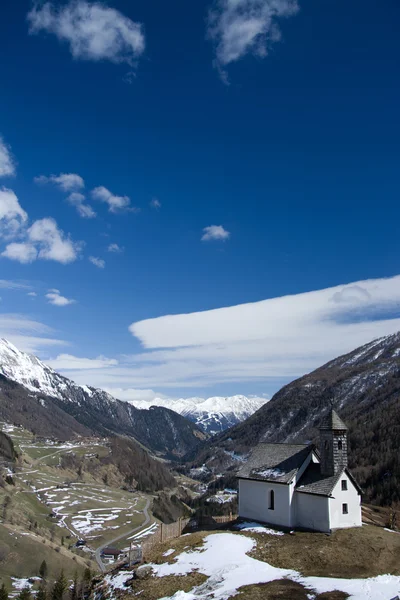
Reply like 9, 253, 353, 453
237, 410, 361, 532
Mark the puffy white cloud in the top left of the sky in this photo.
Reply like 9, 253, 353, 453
27, 0, 145, 66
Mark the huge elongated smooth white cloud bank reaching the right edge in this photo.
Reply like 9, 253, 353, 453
117, 276, 400, 388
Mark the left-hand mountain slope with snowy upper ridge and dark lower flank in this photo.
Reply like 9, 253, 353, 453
0, 340, 206, 458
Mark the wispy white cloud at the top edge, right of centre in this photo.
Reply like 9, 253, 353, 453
207, 0, 299, 80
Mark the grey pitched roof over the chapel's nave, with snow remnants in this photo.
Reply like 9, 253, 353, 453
237, 443, 313, 483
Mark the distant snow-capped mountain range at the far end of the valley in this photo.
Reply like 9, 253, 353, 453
131, 395, 268, 435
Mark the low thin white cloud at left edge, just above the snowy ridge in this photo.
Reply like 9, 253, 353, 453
0, 313, 68, 354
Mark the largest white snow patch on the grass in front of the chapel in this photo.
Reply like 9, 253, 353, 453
151, 533, 400, 600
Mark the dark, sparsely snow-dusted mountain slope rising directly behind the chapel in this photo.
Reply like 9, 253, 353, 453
190, 333, 400, 504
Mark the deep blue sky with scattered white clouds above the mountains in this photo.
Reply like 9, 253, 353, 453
0, 0, 400, 398
